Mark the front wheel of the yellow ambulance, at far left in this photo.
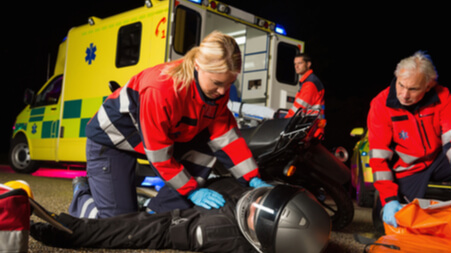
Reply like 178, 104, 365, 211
9, 135, 39, 174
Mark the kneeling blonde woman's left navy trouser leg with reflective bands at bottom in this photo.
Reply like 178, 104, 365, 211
69, 139, 138, 218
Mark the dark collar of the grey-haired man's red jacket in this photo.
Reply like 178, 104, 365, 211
386, 78, 439, 113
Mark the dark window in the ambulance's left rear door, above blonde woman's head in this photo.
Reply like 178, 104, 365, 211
173, 5, 201, 55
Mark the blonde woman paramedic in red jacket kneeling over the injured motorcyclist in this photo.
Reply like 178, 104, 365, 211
69, 32, 266, 218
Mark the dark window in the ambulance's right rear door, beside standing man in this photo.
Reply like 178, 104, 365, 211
276, 42, 300, 85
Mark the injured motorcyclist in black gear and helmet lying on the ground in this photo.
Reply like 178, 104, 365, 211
30, 178, 331, 253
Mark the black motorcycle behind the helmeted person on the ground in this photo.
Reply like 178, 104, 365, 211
221, 109, 354, 230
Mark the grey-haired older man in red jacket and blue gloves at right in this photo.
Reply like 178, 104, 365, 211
367, 52, 451, 226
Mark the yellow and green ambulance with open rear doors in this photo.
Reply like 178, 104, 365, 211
9, 0, 304, 173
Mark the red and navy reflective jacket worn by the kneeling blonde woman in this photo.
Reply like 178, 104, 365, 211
86, 61, 258, 195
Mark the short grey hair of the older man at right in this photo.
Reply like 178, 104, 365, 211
394, 51, 438, 83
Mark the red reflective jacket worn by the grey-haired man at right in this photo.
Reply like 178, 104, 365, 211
367, 79, 451, 205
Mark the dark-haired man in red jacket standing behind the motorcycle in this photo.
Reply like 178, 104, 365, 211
286, 53, 325, 118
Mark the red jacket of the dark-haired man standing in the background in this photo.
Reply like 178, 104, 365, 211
286, 69, 325, 118
